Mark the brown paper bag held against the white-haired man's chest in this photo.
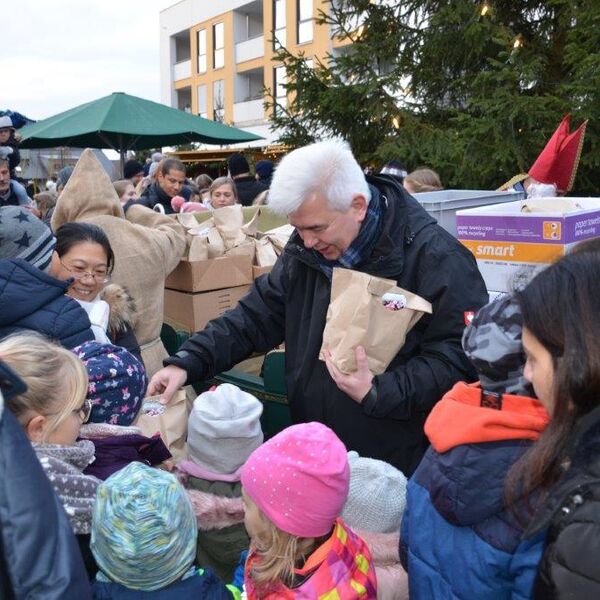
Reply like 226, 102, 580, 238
319, 268, 432, 375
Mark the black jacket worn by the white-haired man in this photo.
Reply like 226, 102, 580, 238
165, 177, 487, 475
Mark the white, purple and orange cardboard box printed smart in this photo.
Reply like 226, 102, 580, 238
456, 198, 600, 292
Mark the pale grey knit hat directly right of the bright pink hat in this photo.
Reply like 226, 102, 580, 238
342, 450, 406, 533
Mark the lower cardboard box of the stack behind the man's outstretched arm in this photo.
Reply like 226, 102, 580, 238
164, 285, 251, 333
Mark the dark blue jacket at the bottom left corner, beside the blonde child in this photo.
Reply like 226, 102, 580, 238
0, 382, 92, 600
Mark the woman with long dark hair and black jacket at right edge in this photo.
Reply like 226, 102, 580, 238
508, 240, 600, 600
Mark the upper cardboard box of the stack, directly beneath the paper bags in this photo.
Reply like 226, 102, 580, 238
165, 256, 252, 292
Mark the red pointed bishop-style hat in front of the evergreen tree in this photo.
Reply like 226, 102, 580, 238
529, 115, 587, 193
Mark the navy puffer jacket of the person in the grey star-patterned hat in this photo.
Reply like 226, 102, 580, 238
0, 258, 94, 348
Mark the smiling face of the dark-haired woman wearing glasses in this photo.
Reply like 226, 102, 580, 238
50, 242, 108, 302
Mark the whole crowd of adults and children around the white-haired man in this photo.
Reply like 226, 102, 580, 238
0, 121, 600, 600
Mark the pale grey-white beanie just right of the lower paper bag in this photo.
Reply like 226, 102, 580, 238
187, 383, 264, 475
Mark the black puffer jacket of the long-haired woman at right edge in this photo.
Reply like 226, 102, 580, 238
527, 407, 600, 600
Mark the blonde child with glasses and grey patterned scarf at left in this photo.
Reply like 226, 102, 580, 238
0, 333, 100, 573
